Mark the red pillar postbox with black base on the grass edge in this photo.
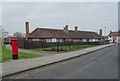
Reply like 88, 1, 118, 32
11, 39, 18, 60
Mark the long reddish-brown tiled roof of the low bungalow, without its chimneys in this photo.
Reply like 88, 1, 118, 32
28, 28, 101, 38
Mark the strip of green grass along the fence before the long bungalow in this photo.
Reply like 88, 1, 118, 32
31, 45, 97, 51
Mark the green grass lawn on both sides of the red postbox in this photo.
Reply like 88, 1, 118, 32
0, 45, 42, 62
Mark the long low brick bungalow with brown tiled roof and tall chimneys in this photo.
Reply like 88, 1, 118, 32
26, 22, 102, 42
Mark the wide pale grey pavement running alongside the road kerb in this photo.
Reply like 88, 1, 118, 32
1, 44, 113, 77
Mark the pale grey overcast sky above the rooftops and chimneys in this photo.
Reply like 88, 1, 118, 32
2, 2, 118, 34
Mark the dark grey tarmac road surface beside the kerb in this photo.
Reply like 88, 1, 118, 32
3, 44, 120, 79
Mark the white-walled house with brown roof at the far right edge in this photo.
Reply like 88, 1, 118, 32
108, 30, 120, 43
